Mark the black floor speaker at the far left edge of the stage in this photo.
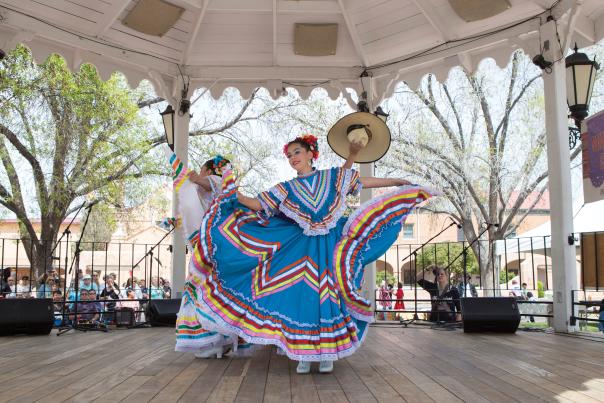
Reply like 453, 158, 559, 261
0, 298, 55, 336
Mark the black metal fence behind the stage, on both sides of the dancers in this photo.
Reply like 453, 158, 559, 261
0, 232, 604, 332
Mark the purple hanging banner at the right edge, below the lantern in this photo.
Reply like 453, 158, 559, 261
581, 111, 604, 203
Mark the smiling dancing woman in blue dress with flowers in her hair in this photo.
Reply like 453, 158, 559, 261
191, 136, 431, 373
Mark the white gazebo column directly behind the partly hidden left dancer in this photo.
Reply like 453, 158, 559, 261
171, 110, 191, 298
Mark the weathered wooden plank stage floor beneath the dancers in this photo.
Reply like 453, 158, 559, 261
0, 326, 604, 403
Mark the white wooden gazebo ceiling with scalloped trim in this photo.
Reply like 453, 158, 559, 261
0, 0, 604, 101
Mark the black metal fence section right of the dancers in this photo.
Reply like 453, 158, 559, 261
374, 232, 604, 330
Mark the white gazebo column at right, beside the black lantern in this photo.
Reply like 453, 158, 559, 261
541, 21, 577, 332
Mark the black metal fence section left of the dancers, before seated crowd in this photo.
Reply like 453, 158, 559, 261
0, 238, 172, 327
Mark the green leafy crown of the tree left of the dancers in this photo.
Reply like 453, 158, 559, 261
0, 46, 161, 217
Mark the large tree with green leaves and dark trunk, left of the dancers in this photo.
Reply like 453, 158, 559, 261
0, 46, 264, 274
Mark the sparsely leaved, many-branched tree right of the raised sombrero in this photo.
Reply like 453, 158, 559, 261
384, 52, 579, 296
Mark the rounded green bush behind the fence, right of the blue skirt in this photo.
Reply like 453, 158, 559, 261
417, 243, 479, 274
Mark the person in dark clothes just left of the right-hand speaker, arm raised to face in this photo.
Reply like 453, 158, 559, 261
417, 265, 461, 322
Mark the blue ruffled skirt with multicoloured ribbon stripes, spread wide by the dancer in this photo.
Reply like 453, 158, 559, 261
186, 172, 431, 361
